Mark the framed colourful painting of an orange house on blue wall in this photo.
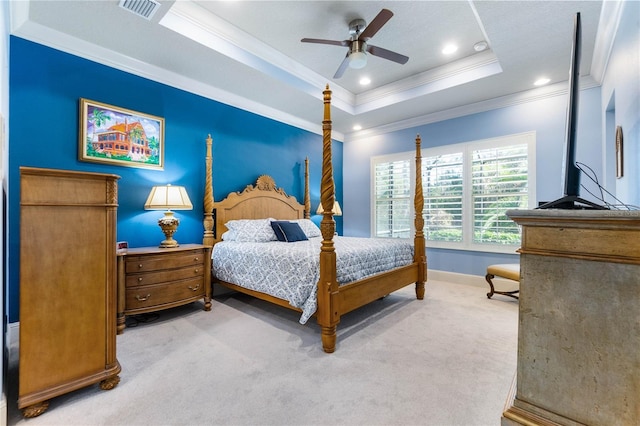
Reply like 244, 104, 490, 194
78, 99, 164, 170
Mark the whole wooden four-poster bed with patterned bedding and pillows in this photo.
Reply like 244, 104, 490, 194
203, 85, 427, 353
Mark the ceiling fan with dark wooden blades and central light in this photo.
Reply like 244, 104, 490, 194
300, 9, 409, 78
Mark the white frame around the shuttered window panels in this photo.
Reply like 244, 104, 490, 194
370, 131, 536, 253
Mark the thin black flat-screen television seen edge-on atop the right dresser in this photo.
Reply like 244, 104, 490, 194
538, 12, 606, 210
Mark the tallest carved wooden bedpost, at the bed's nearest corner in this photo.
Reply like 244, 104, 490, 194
317, 84, 340, 353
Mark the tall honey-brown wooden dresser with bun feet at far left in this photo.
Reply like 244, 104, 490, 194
18, 167, 120, 417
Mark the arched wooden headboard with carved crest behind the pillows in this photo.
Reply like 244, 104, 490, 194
214, 175, 305, 244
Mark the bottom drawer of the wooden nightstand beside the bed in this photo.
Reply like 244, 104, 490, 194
126, 278, 205, 311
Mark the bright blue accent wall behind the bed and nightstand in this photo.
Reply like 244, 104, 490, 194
8, 36, 343, 322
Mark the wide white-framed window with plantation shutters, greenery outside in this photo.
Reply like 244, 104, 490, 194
372, 132, 535, 252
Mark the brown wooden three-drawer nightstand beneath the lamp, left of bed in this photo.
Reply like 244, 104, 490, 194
117, 244, 211, 334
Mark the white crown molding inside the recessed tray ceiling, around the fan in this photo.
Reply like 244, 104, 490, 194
160, 0, 502, 116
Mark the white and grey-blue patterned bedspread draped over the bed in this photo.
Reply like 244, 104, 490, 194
211, 237, 413, 324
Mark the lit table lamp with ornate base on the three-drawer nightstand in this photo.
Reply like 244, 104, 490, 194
144, 184, 193, 248
